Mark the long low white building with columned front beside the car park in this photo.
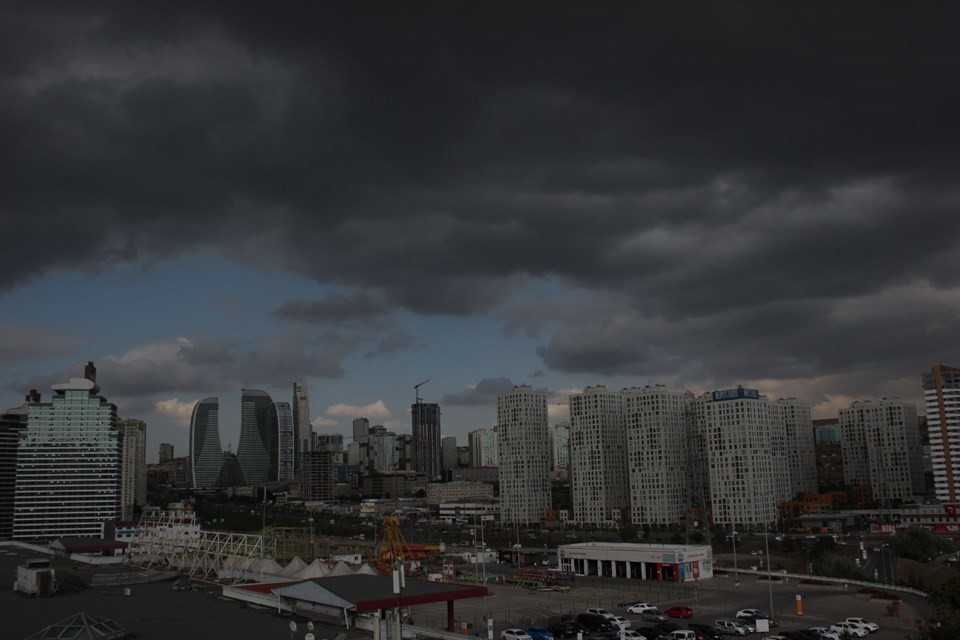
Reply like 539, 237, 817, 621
557, 542, 713, 582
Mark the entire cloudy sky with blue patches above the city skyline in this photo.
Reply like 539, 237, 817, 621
0, 1, 960, 460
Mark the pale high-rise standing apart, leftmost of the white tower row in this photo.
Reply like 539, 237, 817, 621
497, 386, 551, 525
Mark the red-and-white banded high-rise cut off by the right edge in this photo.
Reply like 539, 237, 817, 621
921, 364, 960, 505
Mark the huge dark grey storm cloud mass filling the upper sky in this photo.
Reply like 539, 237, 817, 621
0, 2, 960, 379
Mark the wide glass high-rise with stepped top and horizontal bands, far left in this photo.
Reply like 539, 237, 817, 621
13, 363, 122, 540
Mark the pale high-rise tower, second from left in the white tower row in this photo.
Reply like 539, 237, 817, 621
570, 386, 630, 525
